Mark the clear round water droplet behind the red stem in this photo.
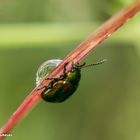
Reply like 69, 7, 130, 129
36, 59, 62, 85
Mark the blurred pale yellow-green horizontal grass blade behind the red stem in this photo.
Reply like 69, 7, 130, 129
0, 20, 140, 49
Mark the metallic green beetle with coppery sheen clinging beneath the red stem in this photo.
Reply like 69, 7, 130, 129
41, 59, 106, 103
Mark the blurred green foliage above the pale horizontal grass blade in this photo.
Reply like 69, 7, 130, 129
0, 0, 132, 23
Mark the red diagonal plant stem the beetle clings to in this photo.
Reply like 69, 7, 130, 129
0, 0, 140, 140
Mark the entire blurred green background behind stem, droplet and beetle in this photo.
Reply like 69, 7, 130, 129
0, 0, 140, 140
